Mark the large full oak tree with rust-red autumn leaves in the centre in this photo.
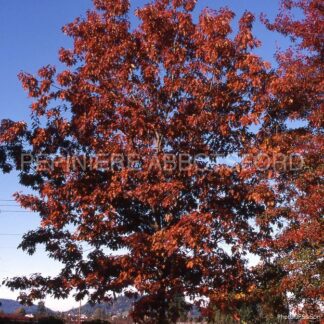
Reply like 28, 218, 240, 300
0, 0, 321, 323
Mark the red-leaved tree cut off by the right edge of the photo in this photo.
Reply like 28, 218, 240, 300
243, 0, 324, 317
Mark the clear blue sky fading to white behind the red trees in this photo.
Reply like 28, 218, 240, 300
0, 0, 287, 310
